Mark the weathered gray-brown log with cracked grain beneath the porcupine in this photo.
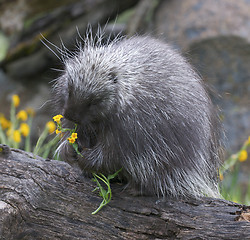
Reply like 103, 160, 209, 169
0, 145, 250, 240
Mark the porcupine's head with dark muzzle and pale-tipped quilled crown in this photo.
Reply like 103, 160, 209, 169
55, 49, 118, 126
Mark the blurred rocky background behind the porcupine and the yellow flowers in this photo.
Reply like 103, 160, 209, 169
0, 0, 250, 202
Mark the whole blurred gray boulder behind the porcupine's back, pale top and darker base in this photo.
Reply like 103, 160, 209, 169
155, 0, 250, 151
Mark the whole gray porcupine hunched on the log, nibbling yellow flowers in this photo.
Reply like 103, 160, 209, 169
54, 30, 220, 198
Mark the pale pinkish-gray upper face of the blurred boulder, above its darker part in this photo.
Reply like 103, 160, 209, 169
155, 0, 250, 50
